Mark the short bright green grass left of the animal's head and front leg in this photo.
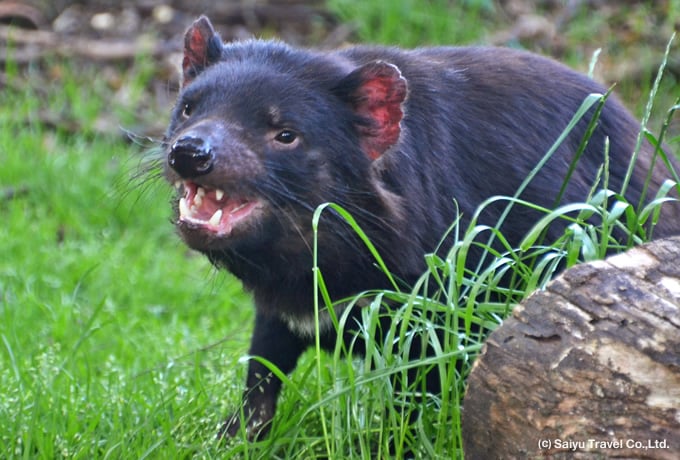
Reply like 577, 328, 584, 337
0, 63, 251, 458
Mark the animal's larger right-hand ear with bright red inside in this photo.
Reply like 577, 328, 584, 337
336, 61, 408, 160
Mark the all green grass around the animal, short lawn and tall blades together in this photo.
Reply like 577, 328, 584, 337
0, 4, 678, 459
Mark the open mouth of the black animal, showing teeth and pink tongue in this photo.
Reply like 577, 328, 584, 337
175, 181, 260, 236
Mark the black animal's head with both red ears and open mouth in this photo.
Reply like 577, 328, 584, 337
165, 17, 408, 262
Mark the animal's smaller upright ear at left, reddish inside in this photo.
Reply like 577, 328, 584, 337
182, 16, 222, 87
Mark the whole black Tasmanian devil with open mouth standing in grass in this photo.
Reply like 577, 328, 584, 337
164, 17, 680, 437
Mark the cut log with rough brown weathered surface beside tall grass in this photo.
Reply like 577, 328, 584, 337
462, 238, 680, 460
